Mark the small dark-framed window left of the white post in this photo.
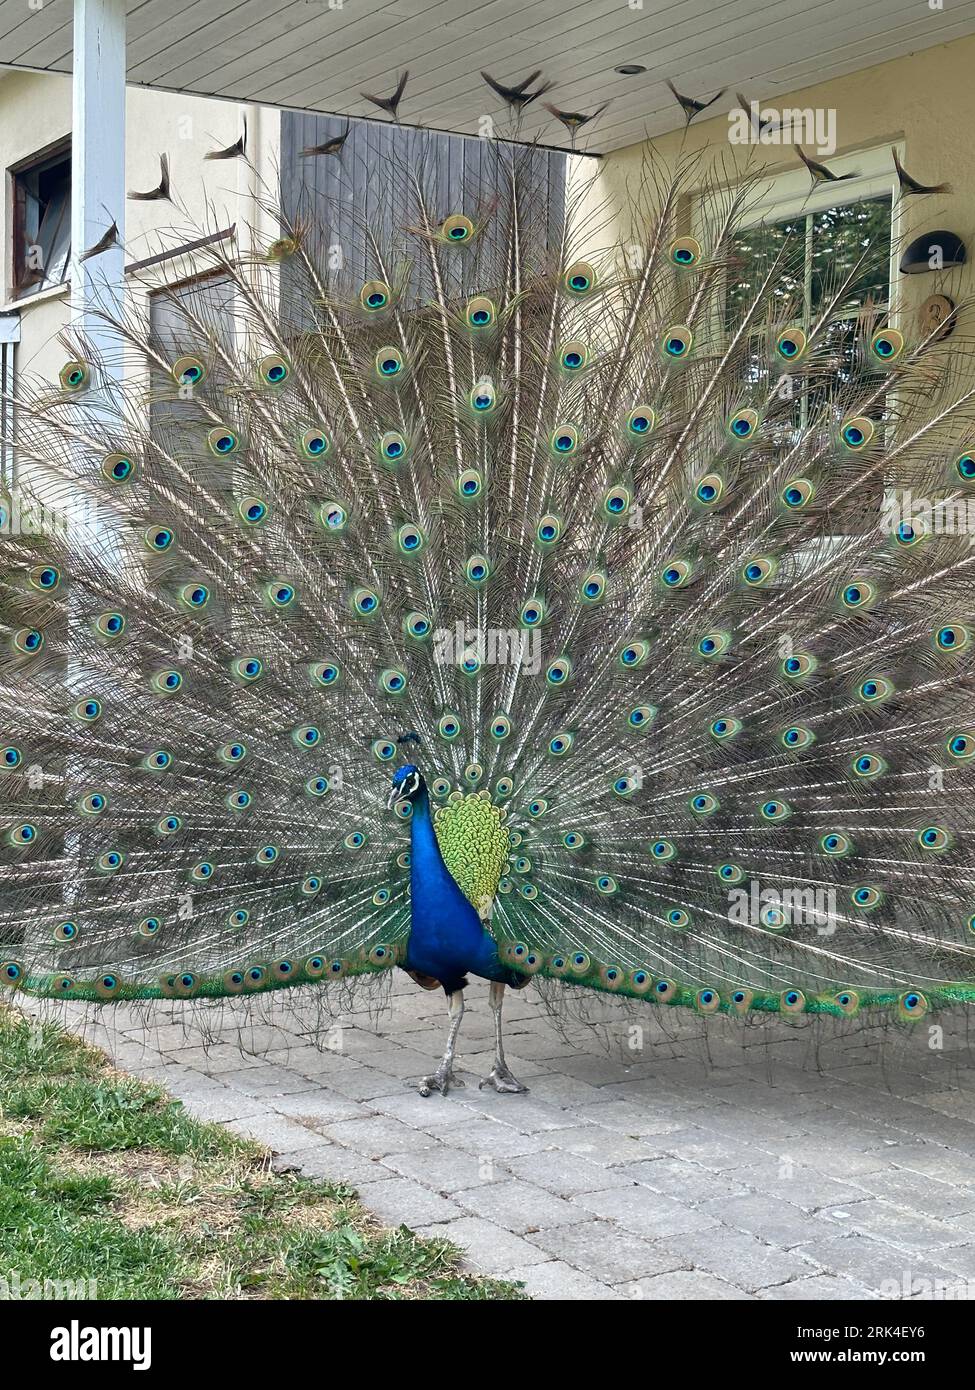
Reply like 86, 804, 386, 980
11, 142, 71, 299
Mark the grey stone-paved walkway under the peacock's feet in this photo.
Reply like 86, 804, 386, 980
24, 977, 975, 1300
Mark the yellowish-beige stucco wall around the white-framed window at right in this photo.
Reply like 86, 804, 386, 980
579, 36, 975, 332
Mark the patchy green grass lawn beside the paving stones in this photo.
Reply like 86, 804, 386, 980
0, 1006, 523, 1300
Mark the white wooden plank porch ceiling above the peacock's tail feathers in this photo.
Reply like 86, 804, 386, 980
0, 0, 975, 152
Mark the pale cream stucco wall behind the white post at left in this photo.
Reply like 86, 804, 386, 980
0, 72, 280, 378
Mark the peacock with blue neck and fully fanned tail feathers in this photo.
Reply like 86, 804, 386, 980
0, 132, 975, 1095
